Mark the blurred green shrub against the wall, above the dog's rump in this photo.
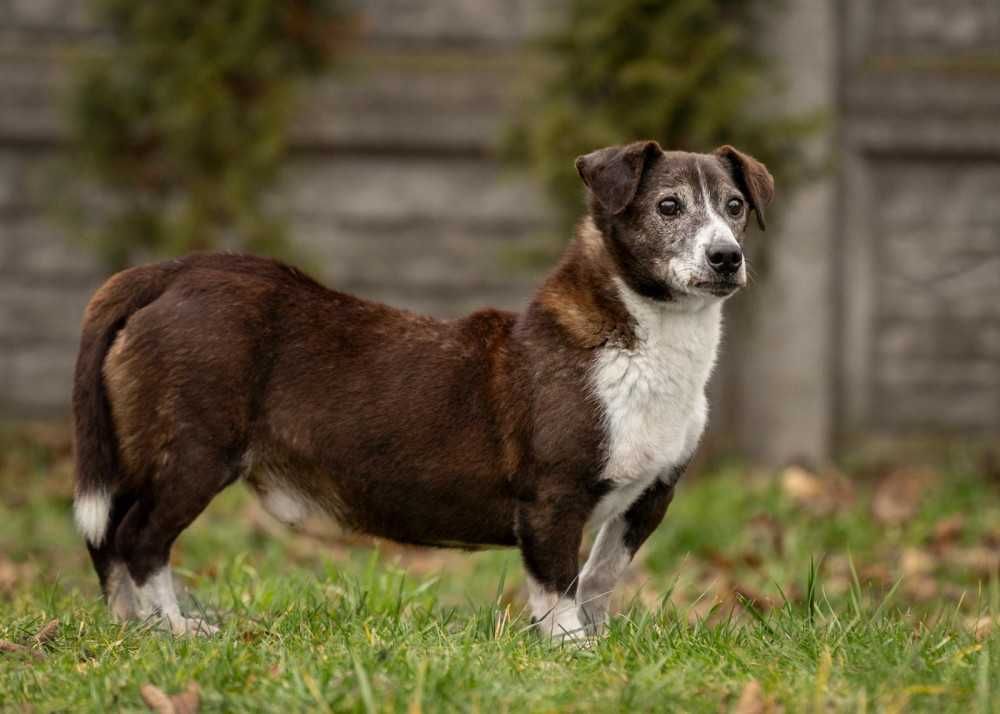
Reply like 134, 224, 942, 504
64, 0, 345, 267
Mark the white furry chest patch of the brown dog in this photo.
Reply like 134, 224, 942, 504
593, 286, 721, 496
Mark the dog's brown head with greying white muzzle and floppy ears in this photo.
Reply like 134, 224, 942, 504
576, 141, 774, 300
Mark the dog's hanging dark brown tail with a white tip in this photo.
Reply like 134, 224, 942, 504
73, 261, 181, 548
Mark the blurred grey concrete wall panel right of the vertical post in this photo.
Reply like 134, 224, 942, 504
835, 0, 1000, 440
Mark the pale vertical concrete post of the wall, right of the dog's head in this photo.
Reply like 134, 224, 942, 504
722, 0, 838, 464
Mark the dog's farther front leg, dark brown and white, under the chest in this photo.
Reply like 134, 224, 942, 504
577, 481, 674, 631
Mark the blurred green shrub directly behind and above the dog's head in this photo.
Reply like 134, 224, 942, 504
507, 0, 817, 239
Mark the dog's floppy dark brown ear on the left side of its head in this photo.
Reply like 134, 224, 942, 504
576, 141, 663, 215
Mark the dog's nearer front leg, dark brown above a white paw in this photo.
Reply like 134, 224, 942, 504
517, 496, 586, 639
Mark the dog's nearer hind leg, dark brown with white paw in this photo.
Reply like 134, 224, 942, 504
115, 445, 235, 635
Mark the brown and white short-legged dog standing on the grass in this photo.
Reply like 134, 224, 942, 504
73, 141, 774, 636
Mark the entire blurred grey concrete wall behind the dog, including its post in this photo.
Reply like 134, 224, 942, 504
0, 0, 1000, 462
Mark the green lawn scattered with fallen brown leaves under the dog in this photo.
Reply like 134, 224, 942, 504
0, 426, 1000, 714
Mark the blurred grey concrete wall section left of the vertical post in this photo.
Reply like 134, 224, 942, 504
0, 0, 547, 416
